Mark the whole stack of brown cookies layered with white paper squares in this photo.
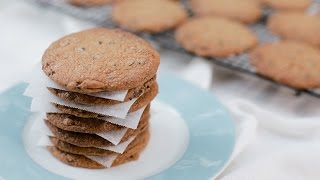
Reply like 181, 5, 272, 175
42, 28, 160, 168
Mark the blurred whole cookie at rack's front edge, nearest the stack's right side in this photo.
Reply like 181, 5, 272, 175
175, 17, 257, 57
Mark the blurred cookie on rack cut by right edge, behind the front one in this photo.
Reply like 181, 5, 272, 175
268, 12, 320, 48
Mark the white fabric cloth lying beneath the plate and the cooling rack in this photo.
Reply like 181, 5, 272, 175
0, 1, 320, 180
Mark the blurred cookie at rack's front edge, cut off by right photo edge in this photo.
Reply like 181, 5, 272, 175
250, 41, 320, 89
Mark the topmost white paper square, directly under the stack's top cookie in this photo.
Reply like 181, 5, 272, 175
26, 62, 128, 101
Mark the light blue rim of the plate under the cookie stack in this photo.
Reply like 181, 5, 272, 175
0, 73, 235, 180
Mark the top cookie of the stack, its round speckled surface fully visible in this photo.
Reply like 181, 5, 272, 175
42, 28, 160, 93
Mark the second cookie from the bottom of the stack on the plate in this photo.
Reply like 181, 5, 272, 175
50, 125, 149, 156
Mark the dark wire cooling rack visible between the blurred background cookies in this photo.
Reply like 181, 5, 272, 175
29, 0, 320, 98
